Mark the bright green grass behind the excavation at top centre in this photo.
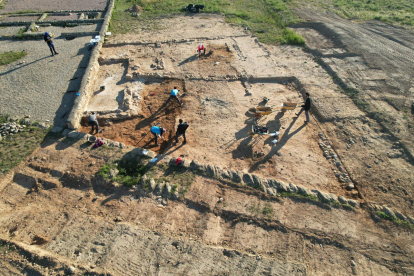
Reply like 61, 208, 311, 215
110, 0, 305, 45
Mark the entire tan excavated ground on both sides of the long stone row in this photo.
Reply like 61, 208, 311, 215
0, 14, 414, 275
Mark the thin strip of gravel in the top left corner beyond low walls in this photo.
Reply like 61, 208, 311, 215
0, 0, 107, 13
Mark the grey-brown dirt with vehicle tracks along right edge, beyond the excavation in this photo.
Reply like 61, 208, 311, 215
297, 10, 414, 210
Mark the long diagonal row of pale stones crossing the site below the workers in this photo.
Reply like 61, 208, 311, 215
56, 126, 414, 225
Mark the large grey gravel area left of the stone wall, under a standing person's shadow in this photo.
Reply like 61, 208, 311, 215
0, 36, 91, 126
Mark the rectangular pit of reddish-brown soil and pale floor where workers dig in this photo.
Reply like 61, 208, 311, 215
79, 76, 184, 153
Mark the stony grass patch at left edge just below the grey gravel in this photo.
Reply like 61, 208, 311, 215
0, 116, 48, 175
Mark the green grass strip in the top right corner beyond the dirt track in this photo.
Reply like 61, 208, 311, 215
321, 0, 414, 26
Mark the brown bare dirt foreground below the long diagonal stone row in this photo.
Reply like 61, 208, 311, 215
0, 138, 414, 275
